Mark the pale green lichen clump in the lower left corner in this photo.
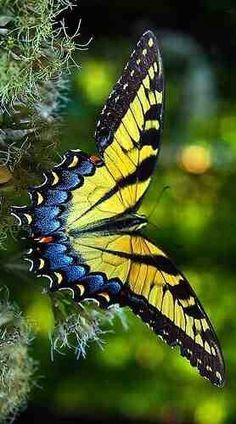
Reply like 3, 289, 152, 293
0, 290, 36, 423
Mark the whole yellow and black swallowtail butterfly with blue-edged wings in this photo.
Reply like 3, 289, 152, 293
12, 31, 225, 386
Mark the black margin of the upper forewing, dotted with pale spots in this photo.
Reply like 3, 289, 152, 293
95, 31, 164, 156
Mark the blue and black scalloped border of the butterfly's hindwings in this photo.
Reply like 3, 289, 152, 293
13, 153, 120, 298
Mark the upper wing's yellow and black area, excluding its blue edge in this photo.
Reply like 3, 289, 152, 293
67, 31, 163, 230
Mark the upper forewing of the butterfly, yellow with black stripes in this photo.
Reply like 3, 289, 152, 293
95, 31, 164, 209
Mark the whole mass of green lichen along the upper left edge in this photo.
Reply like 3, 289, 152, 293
0, 0, 82, 247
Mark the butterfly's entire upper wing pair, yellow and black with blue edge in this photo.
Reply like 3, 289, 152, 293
12, 31, 163, 235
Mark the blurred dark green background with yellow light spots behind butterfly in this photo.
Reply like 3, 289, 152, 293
4, 0, 236, 424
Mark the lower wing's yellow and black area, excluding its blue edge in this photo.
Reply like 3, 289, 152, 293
71, 234, 224, 386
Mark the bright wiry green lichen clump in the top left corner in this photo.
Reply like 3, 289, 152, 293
0, 0, 76, 107
